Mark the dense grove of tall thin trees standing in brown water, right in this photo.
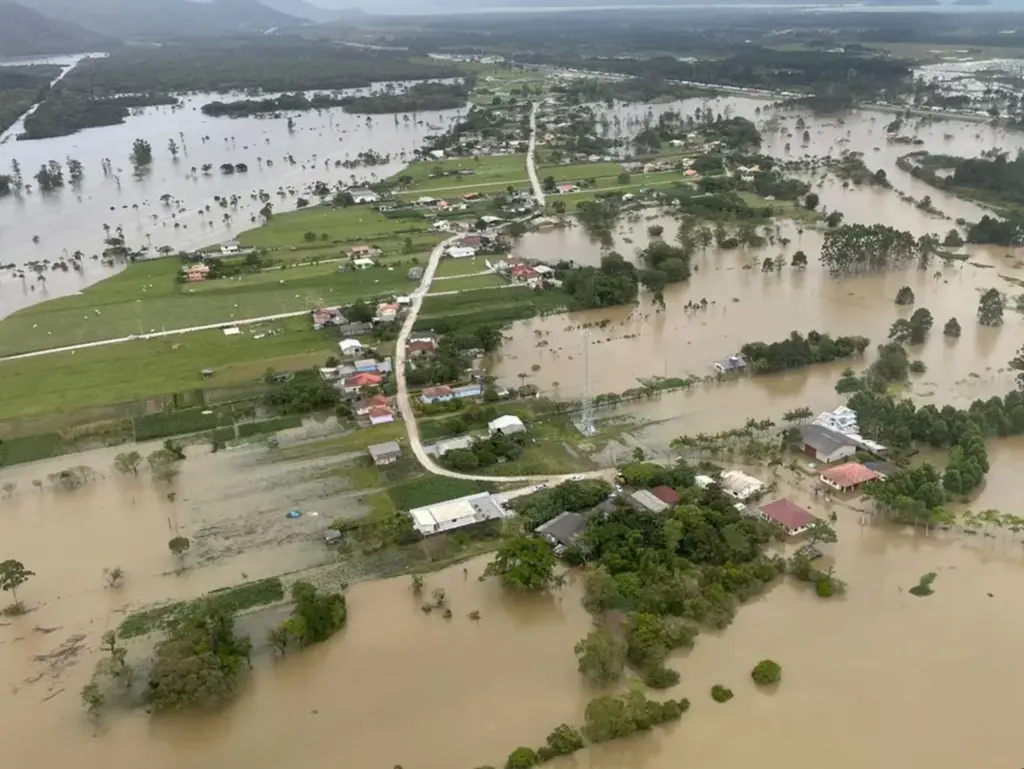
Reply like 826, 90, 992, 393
821, 224, 938, 276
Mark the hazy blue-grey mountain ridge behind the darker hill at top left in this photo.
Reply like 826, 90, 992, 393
23, 0, 302, 40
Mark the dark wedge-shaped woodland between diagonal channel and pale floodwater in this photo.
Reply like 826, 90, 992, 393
17, 92, 178, 139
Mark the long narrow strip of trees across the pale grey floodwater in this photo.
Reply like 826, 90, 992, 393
202, 83, 470, 118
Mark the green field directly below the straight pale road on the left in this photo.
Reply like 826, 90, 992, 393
0, 317, 337, 420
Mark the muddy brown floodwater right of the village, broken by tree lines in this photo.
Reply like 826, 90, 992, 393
494, 99, 1024, 436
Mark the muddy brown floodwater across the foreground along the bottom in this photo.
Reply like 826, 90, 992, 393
6, 442, 1024, 769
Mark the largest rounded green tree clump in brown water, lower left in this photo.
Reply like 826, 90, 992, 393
148, 602, 252, 711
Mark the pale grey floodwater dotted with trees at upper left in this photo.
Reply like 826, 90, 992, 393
0, 86, 462, 316
